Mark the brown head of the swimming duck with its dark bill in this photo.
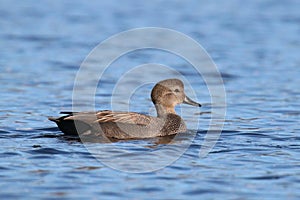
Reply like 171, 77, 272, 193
151, 79, 201, 115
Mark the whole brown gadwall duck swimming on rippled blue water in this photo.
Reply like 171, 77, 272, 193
49, 79, 201, 139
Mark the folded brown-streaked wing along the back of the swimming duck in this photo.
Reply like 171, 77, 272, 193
63, 110, 152, 126
